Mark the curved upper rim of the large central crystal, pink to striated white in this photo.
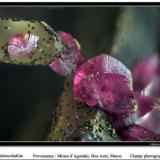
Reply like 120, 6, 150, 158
73, 54, 132, 102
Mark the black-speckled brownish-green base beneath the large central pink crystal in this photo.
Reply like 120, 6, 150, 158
47, 75, 120, 141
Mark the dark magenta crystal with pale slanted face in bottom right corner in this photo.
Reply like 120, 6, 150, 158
117, 102, 160, 141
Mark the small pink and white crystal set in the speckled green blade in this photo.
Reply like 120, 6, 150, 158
8, 34, 39, 56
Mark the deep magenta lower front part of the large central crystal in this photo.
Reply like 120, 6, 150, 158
74, 73, 134, 114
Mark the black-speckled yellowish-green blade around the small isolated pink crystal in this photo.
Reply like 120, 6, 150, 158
0, 18, 66, 65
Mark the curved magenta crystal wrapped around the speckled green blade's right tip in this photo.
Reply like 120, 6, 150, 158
49, 31, 84, 76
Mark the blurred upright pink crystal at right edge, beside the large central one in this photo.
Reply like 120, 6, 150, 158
133, 55, 160, 116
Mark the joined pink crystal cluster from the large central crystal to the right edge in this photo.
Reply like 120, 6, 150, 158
73, 54, 160, 141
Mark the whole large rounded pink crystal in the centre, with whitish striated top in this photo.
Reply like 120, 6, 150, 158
73, 54, 135, 114
